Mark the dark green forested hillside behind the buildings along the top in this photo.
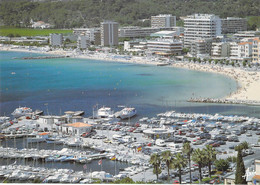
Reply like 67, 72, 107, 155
0, 0, 260, 28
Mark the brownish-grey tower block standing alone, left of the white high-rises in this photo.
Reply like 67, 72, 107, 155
100, 21, 118, 46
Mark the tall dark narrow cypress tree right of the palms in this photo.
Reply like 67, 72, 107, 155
235, 149, 246, 184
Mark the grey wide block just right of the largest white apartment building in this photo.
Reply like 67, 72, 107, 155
221, 17, 247, 34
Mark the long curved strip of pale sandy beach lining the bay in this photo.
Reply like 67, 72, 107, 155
0, 46, 260, 102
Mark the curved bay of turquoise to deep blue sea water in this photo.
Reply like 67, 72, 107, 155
0, 52, 258, 116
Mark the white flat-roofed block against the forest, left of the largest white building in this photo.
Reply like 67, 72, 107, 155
151, 14, 176, 28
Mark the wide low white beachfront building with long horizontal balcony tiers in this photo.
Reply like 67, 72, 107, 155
147, 39, 183, 55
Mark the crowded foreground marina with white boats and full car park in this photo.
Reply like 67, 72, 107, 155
0, 104, 260, 183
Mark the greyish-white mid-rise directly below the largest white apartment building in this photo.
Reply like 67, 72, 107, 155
190, 39, 212, 57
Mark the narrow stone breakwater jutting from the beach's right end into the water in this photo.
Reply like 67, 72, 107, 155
188, 98, 260, 106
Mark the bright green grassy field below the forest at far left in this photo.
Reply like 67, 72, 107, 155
0, 26, 72, 37
